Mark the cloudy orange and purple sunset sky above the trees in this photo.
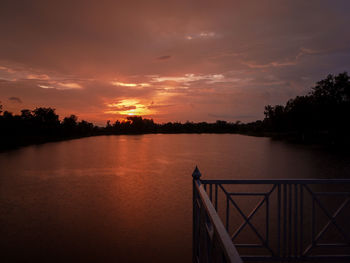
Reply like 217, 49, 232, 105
0, 0, 350, 125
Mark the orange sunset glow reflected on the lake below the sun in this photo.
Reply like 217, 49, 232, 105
105, 136, 187, 261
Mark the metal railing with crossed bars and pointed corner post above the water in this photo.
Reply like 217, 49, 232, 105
192, 167, 350, 262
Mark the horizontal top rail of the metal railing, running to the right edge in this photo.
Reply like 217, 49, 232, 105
200, 179, 350, 184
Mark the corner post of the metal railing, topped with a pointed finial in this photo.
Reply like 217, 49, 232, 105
192, 166, 202, 263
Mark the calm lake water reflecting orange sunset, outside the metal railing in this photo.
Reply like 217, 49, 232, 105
0, 134, 350, 262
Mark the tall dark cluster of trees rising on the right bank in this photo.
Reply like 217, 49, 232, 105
263, 72, 350, 145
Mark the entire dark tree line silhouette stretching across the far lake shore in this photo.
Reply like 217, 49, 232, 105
0, 72, 350, 150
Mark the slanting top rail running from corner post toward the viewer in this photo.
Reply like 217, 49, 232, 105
194, 179, 242, 263
